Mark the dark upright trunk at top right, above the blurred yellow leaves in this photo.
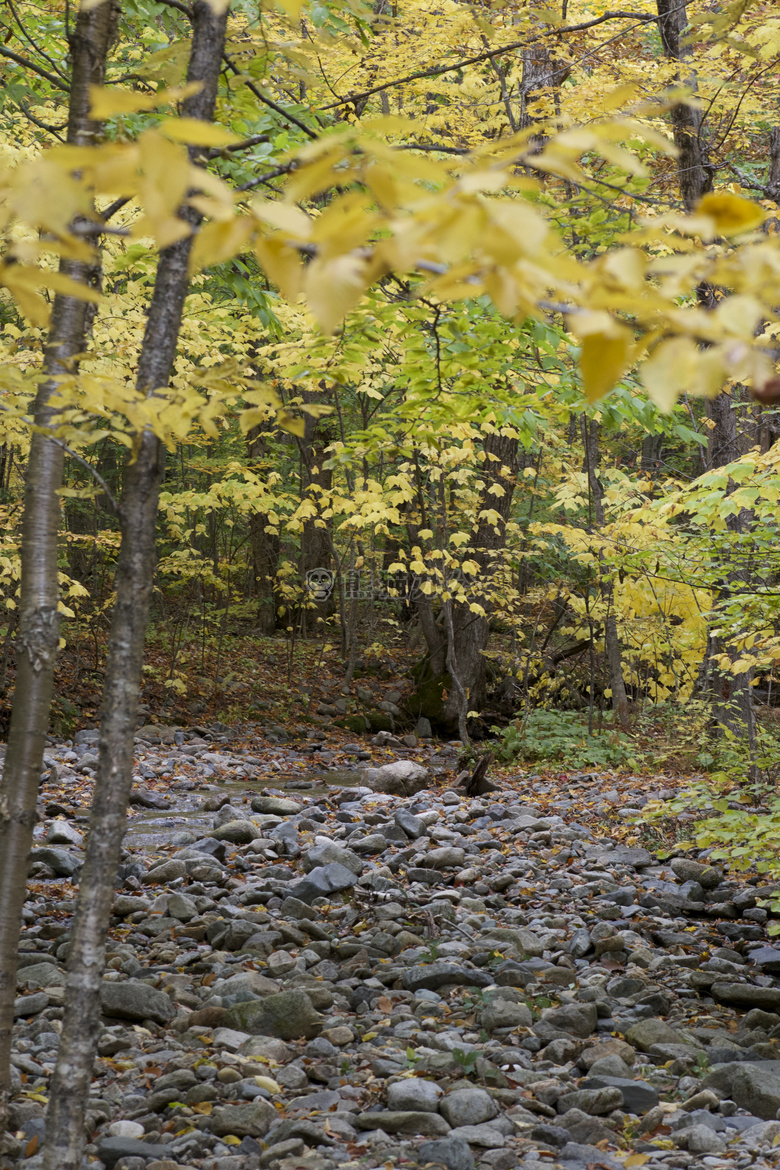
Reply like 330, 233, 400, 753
656, 0, 713, 212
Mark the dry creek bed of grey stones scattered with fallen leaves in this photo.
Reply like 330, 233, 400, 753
9, 725, 780, 1170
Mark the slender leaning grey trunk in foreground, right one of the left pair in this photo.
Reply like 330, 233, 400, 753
43, 0, 227, 1170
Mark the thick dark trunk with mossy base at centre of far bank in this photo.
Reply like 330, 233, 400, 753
444, 432, 518, 729
